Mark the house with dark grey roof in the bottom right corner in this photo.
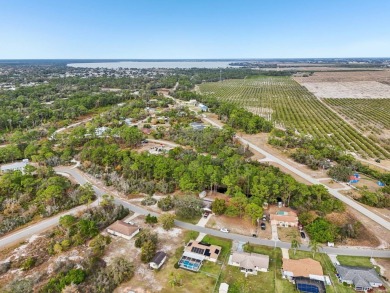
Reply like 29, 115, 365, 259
335, 265, 383, 291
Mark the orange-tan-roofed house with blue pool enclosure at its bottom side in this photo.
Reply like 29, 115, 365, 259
282, 258, 326, 282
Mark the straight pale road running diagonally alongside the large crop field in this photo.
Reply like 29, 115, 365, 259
202, 117, 390, 230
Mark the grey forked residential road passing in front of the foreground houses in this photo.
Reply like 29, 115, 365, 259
0, 167, 390, 258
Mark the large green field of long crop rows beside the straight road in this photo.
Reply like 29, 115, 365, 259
199, 76, 390, 158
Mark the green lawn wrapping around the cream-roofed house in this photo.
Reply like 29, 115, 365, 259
220, 245, 297, 293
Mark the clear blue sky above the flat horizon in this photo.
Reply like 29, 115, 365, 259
0, 0, 390, 59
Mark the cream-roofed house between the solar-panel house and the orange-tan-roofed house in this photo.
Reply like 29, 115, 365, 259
228, 252, 269, 275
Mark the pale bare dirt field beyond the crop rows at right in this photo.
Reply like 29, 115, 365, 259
301, 81, 390, 99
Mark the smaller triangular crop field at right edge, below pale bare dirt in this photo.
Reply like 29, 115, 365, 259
324, 99, 390, 135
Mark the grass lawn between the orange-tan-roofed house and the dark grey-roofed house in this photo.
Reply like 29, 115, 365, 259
289, 250, 355, 293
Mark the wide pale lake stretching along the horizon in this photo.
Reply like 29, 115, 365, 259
67, 61, 234, 69
